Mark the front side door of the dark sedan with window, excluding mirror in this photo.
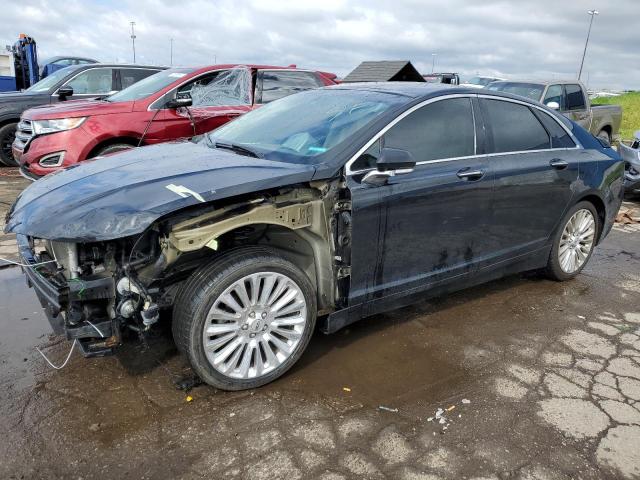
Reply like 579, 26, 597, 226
349, 97, 494, 315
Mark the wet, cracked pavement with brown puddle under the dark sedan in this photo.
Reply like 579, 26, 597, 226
0, 172, 640, 480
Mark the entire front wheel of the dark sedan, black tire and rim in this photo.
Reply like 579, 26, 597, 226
172, 247, 317, 390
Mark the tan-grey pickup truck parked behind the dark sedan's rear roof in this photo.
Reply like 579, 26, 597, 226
487, 80, 622, 143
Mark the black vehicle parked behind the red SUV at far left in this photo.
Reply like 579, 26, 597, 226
0, 63, 164, 166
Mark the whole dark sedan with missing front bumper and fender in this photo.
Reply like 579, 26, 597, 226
6, 83, 624, 390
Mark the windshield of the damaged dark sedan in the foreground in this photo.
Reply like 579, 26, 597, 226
207, 88, 407, 164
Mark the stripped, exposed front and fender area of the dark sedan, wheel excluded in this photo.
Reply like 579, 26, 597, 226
20, 180, 351, 356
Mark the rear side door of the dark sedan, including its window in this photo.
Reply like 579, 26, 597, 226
480, 97, 579, 261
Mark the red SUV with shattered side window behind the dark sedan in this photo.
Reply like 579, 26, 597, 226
13, 65, 335, 179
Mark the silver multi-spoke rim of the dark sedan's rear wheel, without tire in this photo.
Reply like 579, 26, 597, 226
558, 208, 596, 273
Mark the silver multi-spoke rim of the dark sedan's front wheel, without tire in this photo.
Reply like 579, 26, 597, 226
202, 272, 307, 379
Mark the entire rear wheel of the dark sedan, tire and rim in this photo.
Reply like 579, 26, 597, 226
545, 201, 601, 281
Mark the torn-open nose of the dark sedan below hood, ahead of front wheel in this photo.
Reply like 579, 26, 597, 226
17, 235, 164, 357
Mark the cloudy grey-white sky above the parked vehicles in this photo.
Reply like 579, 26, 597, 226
5, 0, 640, 89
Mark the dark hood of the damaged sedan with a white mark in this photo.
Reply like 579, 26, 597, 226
5, 142, 315, 242
